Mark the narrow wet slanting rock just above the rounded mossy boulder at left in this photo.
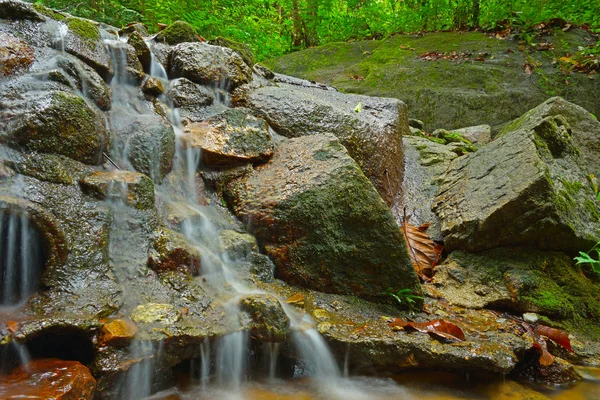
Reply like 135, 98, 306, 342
56, 56, 111, 111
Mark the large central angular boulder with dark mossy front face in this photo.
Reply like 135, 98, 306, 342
225, 135, 420, 298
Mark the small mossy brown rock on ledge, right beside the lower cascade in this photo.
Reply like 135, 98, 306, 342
239, 294, 290, 342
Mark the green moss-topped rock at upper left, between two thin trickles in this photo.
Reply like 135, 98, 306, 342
64, 16, 113, 80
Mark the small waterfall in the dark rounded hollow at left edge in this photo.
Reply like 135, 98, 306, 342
0, 210, 45, 306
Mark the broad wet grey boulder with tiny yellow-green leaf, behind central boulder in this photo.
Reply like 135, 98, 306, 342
237, 75, 409, 205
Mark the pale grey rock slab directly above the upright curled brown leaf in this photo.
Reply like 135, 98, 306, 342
399, 136, 458, 240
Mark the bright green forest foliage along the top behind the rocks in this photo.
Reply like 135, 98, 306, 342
38, 0, 600, 61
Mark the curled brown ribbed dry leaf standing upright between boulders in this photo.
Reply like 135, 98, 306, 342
402, 211, 444, 282
